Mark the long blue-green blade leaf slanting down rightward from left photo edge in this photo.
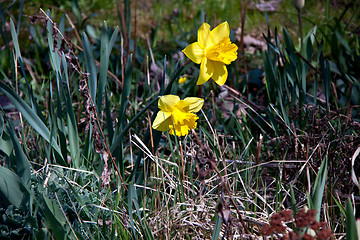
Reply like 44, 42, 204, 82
0, 82, 64, 159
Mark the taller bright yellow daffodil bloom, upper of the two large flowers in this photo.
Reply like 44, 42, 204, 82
183, 22, 238, 86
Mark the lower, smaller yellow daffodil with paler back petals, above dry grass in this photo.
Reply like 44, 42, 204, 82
152, 95, 204, 136
